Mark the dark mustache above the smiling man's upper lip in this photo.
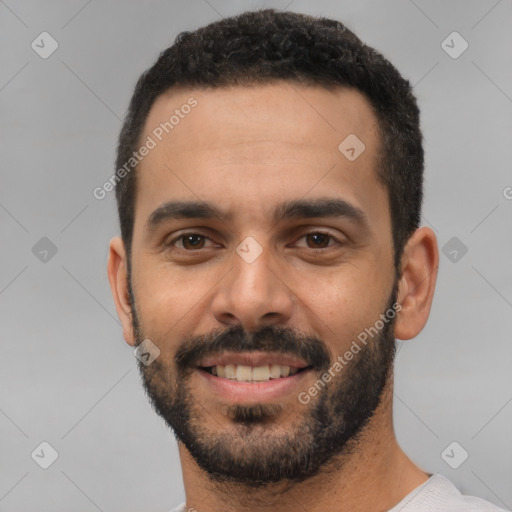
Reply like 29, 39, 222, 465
174, 325, 332, 372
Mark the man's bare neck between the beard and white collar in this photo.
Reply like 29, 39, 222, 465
179, 384, 429, 512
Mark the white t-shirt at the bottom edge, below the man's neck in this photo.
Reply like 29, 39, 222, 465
170, 473, 507, 512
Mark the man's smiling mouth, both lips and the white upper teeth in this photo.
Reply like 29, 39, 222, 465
197, 352, 313, 403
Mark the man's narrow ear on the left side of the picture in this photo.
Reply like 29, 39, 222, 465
107, 237, 135, 346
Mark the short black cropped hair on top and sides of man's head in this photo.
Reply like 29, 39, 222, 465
116, 9, 424, 269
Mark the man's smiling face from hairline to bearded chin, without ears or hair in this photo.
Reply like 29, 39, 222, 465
129, 83, 397, 486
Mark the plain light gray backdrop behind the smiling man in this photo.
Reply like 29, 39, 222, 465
0, 0, 512, 512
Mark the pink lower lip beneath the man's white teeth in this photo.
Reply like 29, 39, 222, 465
197, 369, 311, 403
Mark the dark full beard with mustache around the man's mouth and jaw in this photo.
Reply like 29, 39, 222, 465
128, 278, 398, 488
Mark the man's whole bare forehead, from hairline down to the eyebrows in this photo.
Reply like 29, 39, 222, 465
132, 82, 387, 236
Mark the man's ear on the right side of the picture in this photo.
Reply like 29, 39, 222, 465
395, 226, 439, 340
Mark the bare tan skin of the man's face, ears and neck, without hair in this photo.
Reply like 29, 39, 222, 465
108, 82, 439, 512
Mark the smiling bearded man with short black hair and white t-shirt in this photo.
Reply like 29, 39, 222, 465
108, 9, 506, 512
